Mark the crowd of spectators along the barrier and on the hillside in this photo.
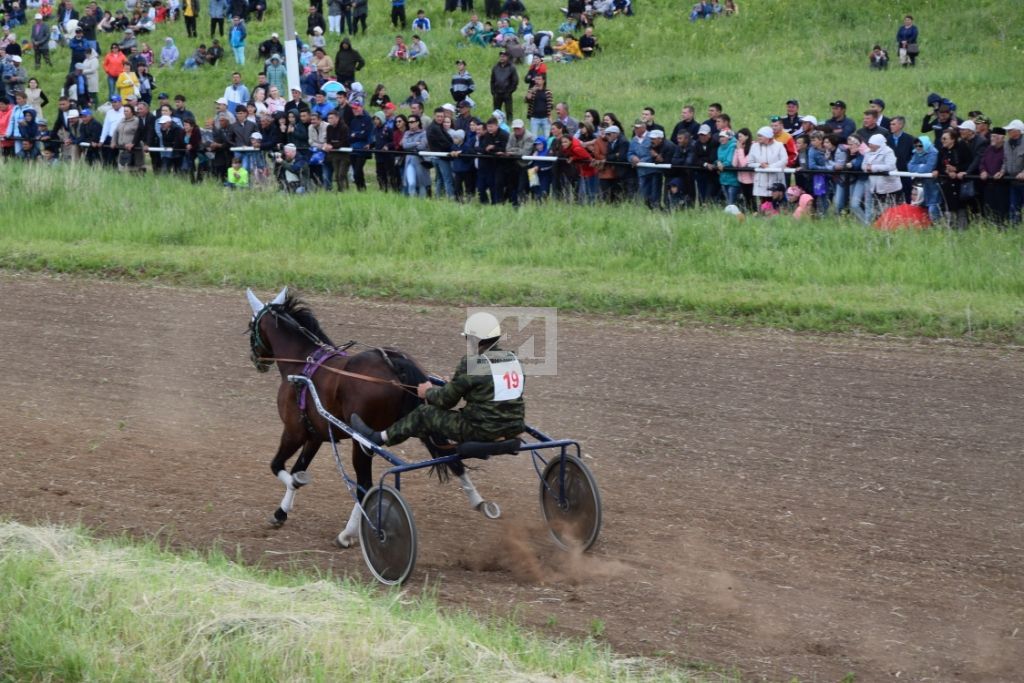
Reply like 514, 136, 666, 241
0, 0, 1024, 227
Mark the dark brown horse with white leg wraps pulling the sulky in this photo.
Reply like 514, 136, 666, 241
247, 288, 466, 548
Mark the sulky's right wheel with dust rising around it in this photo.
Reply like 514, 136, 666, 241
541, 454, 601, 550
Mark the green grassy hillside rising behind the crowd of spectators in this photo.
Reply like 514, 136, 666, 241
20, 0, 1024, 128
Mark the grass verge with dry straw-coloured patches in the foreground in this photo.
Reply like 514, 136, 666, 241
0, 522, 734, 683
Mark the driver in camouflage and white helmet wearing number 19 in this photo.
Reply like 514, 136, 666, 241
349, 312, 526, 445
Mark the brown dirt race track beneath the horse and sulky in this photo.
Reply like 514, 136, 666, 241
0, 273, 1024, 681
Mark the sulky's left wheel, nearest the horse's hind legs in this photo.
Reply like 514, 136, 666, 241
359, 484, 416, 586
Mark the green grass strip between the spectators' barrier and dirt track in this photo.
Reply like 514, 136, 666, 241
0, 166, 1024, 343
